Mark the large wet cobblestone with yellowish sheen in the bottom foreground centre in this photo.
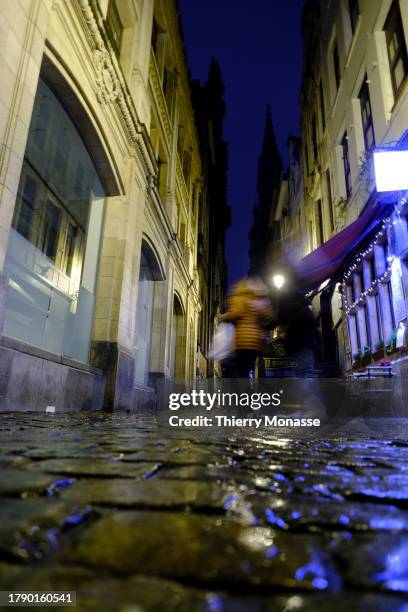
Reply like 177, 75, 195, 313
66, 511, 339, 590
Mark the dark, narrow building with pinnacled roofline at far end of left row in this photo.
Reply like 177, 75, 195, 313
193, 59, 231, 378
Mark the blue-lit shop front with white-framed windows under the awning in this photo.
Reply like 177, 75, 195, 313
343, 196, 408, 367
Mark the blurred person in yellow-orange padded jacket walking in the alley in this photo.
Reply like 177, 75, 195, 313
222, 277, 273, 378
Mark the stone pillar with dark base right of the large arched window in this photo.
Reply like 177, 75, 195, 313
92, 164, 146, 407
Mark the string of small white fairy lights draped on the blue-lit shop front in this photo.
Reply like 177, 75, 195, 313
343, 197, 408, 314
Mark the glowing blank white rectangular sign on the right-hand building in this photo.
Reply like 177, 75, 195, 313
374, 149, 408, 191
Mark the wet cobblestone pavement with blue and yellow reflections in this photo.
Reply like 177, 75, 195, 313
0, 413, 408, 612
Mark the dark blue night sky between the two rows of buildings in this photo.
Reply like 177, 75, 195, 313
179, 0, 303, 282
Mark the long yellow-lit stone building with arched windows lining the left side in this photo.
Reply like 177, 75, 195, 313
0, 0, 226, 410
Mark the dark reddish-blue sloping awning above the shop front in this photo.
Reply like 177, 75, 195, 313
297, 202, 388, 289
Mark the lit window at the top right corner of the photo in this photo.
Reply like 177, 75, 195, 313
384, 0, 408, 97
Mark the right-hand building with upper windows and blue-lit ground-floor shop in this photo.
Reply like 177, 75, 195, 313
294, 0, 408, 372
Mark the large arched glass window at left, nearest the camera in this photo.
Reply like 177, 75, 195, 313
3, 79, 105, 362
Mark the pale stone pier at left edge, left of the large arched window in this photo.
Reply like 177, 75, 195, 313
0, 0, 52, 329
